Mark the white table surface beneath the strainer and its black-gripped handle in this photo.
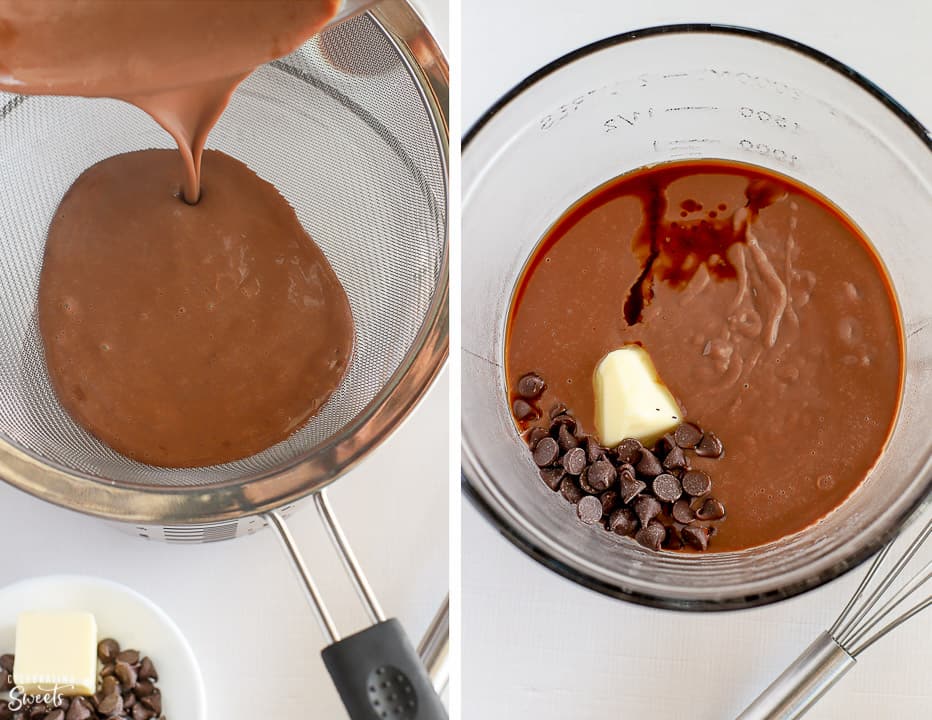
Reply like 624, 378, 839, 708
0, 0, 449, 720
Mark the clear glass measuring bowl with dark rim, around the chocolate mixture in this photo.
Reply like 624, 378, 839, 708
462, 25, 932, 610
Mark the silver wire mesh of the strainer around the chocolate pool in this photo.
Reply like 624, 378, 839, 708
0, 16, 446, 486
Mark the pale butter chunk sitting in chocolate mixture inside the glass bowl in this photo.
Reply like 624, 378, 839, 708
592, 345, 683, 447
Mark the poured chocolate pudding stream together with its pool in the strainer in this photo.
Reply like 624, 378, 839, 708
0, 0, 354, 467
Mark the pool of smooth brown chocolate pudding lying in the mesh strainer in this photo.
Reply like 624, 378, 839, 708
39, 150, 353, 467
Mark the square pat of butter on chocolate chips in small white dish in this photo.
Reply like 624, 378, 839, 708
13, 612, 97, 696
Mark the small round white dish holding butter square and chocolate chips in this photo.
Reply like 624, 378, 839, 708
0, 575, 207, 720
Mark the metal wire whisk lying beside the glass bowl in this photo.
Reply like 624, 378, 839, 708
737, 519, 932, 720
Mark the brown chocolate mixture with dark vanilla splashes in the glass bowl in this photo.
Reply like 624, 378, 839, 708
505, 161, 903, 551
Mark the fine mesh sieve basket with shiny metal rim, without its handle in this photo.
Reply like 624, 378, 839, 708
0, 3, 447, 524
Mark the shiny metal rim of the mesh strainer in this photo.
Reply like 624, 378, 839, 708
0, 0, 449, 525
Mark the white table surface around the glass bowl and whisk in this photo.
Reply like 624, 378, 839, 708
462, 0, 932, 720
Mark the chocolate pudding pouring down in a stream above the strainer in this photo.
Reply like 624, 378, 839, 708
0, 0, 341, 203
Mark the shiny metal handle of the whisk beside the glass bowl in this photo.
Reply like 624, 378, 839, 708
737, 632, 855, 720
